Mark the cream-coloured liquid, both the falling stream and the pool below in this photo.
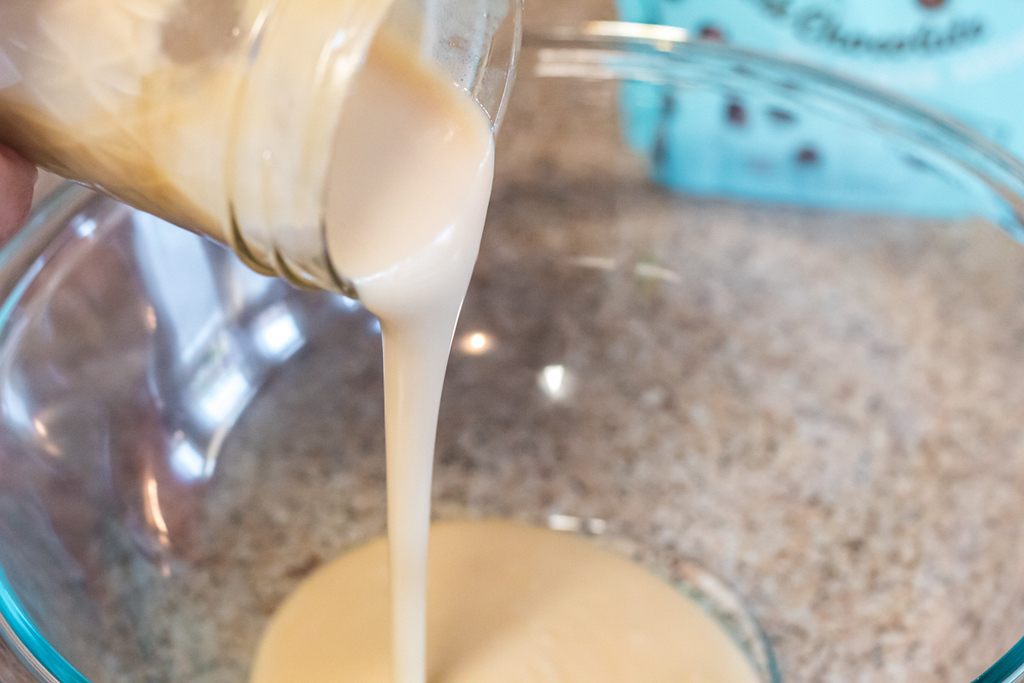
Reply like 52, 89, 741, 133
251, 26, 758, 683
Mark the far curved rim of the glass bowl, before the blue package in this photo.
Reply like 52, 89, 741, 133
523, 22, 1024, 243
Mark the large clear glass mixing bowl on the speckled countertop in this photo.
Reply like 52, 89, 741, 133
0, 24, 1024, 683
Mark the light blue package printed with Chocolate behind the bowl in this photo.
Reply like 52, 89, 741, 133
616, 0, 1024, 217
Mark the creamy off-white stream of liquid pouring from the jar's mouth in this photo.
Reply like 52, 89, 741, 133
326, 39, 494, 683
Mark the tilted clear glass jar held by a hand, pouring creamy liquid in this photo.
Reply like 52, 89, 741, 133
0, 0, 519, 295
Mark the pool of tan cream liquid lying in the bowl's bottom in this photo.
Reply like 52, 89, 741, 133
252, 521, 759, 683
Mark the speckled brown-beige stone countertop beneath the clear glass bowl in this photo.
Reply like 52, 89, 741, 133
6, 2, 1024, 683
